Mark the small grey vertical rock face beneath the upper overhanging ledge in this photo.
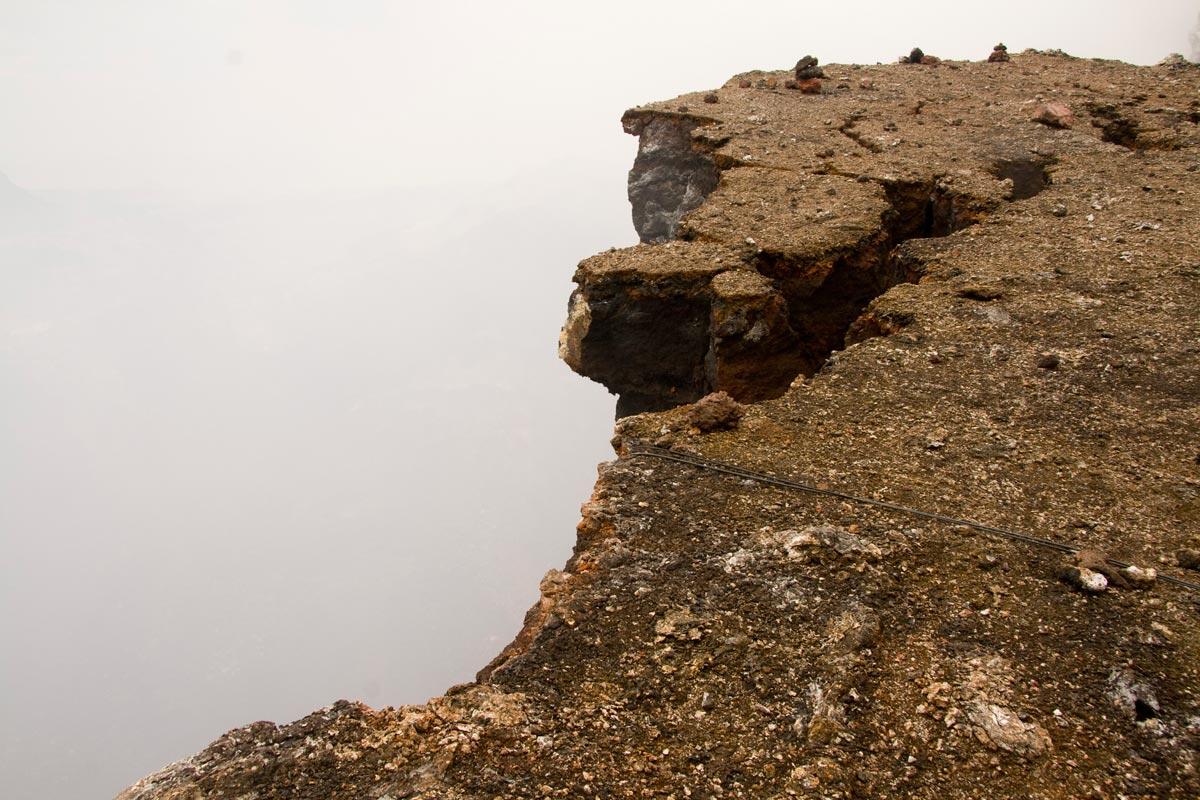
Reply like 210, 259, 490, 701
625, 115, 719, 242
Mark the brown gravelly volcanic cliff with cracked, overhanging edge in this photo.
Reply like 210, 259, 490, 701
121, 52, 1200, 800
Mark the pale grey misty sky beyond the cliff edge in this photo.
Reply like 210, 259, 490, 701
0, 0, 1200, 800
